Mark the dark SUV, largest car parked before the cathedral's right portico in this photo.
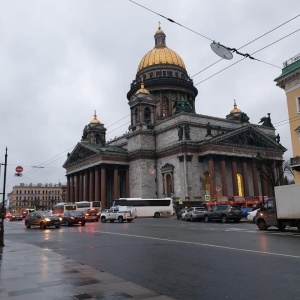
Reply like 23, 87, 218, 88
204, 204, 243, 223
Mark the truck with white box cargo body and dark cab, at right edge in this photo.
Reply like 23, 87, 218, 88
255, 184, 300, 231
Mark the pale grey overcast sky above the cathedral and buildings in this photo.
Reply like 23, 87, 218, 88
0, 0, 300, 192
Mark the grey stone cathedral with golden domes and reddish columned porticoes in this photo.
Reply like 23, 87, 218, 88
63, 27, 286, 207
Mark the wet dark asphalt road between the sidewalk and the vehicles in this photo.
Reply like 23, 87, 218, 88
5, 217, 300, 300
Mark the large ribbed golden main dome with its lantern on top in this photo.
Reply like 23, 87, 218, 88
137, 26, 185, 72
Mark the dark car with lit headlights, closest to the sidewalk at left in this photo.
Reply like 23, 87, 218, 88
25, 211, 61, 229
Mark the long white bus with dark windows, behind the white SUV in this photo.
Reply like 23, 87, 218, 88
113, 198, 173, 218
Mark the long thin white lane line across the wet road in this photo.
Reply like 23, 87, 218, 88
95, 231, 300, 258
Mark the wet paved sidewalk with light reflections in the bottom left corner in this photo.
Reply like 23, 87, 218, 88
0, 241, 172, 300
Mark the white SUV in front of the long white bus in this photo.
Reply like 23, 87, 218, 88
100, 206, 136, 223
